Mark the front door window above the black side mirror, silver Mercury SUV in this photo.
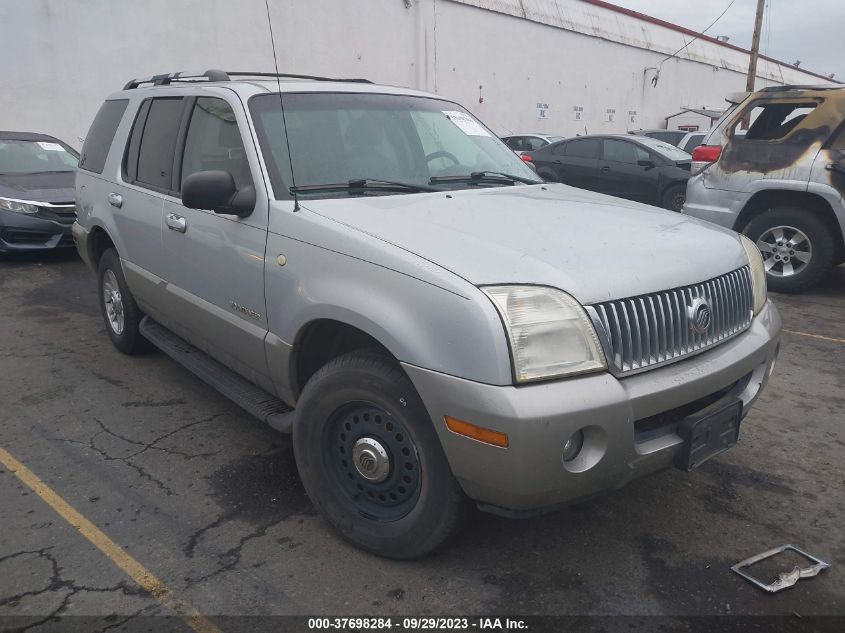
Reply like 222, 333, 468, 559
179, 97, 252, 190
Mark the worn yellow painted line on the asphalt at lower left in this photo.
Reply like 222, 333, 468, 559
0, 448, 222, 633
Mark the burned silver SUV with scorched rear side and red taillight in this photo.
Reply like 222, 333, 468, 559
683, 86, 845, 292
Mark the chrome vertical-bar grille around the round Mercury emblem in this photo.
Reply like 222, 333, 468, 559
589, 266, 754, 374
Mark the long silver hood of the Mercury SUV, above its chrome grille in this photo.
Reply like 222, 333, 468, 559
300, 184, 747, 305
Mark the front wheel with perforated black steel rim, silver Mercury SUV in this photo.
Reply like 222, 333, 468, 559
293, 351, 467, 559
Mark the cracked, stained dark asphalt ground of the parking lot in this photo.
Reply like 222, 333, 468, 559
0, 249, 845, 631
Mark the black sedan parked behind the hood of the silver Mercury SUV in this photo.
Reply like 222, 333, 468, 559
522, 135, 692, 211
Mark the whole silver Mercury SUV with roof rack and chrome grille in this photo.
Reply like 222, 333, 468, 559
74, 71, 781, 558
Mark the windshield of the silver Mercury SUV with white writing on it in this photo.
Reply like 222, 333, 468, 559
250, 93, 541, 198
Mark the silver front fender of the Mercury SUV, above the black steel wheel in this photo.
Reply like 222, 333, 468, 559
265, 234, 512, 385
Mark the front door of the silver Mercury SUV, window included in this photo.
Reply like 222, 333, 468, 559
162, 95, 272, 388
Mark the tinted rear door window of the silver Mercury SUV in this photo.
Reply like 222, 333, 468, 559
133, 97, 183, 191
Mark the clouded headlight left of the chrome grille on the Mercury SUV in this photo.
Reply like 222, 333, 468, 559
482, 286, 607, 382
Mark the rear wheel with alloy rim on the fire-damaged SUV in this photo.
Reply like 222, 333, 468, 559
744, 207, 836, 293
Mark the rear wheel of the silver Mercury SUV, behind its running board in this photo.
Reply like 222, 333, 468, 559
97, 248, 152, 355
